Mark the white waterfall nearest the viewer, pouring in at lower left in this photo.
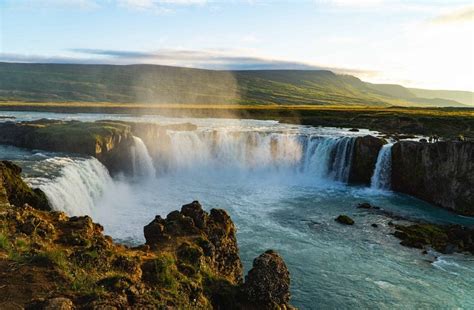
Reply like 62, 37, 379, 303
39, 157, 113, 216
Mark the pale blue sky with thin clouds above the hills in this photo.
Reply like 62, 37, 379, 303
0, 0, 474, 91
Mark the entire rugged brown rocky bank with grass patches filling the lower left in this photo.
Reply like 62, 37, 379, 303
0, 162, 291, 309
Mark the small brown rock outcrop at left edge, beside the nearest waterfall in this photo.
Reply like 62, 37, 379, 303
0, 161, 51, 210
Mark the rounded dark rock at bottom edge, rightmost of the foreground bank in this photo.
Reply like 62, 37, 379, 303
243, 250, 290, 309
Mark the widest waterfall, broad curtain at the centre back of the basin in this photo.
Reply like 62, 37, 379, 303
149, 130, 355, 182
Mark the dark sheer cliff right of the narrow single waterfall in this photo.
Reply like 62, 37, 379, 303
392, 141, 474, 215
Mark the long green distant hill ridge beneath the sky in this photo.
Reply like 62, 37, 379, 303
0, 63, 472, 106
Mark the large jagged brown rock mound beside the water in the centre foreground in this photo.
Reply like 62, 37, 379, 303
144, 201, 242, 283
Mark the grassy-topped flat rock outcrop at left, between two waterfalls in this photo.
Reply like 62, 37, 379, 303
0, 119, 133, 173
